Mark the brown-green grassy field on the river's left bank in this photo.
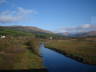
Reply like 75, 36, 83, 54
0, 36, 44, 70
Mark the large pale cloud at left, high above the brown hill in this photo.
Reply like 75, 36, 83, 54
0, 7, 35, 23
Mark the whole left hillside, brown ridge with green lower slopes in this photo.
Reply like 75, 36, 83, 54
0, 26, 64, 39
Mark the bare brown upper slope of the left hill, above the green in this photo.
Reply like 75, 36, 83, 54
0, 26, 52, 33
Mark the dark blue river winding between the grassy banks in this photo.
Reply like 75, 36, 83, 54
40, 44, 96, 72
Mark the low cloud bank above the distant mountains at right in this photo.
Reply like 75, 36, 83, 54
58, 24, 96, 32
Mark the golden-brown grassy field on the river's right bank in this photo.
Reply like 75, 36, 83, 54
45, 38, 96, 65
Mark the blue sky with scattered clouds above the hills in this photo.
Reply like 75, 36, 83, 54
0, 0, 96, 32
